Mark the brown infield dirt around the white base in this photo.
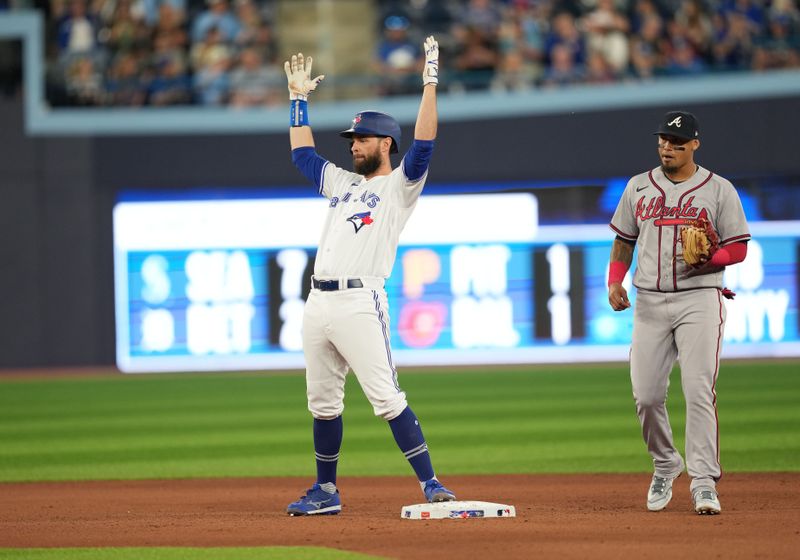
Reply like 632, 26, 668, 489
0, 473, 800, 559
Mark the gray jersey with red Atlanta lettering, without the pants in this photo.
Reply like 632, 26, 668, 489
610, 166, 750, 292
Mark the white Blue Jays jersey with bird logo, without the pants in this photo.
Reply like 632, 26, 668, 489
314, 162, 428, 279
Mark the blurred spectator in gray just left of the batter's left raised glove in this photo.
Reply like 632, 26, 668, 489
230, 47, 286, 107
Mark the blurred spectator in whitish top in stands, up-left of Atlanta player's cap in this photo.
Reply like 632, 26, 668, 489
582, 0, 630, 75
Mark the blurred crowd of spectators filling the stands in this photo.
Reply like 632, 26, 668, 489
7, 0, 800, 107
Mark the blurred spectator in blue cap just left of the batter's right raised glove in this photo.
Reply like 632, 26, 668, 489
375, 15, 422, 95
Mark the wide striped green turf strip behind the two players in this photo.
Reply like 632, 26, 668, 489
0, 361, 800, 481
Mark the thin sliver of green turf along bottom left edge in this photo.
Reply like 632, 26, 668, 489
0, 546, 380, 560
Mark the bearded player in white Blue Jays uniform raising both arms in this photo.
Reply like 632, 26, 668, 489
285, 37, 455, 515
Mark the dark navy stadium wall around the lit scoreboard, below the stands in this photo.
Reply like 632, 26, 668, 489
0, 96, 800, 367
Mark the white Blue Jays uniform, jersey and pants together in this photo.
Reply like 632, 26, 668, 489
303, 158, 428, 420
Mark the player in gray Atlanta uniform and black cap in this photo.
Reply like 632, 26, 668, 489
608, 111, 750, 514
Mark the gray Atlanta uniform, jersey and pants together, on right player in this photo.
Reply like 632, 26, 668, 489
610, 166, 750, 490
